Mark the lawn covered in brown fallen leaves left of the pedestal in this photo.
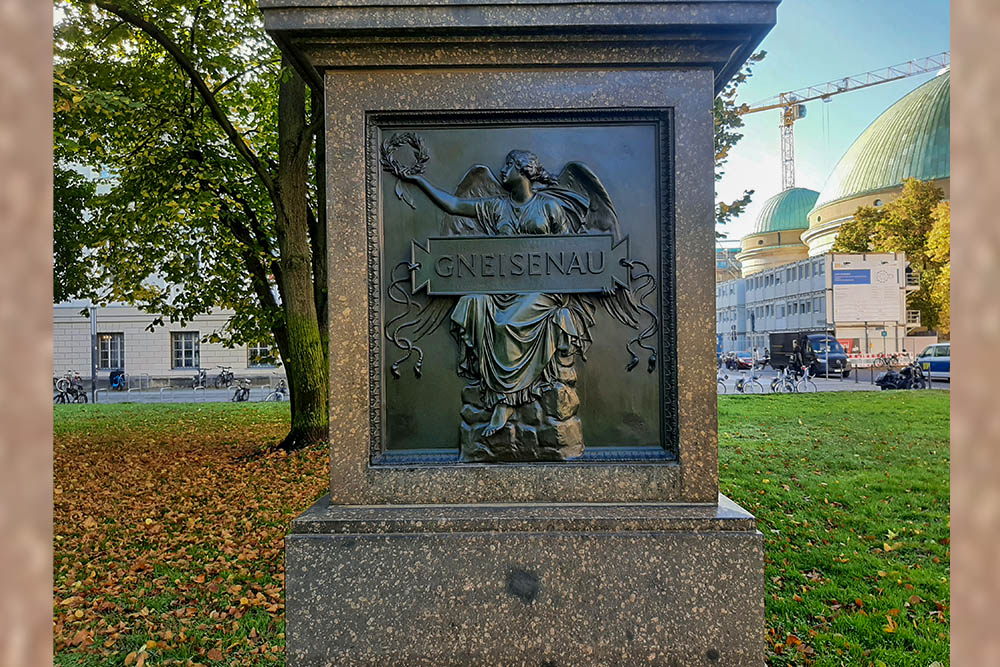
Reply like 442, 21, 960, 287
54, 404, 329, 667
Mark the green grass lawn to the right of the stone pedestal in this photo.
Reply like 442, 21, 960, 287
719, 391, 950, 667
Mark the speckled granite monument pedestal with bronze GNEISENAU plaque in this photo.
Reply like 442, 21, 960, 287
259, 0, 778, 667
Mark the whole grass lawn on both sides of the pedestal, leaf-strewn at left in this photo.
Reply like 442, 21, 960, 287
54, 391, 949, 667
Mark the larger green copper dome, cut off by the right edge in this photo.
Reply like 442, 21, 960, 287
813, 70, 951, 211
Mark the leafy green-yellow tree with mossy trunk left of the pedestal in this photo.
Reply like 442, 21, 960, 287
54, 0, 328, 448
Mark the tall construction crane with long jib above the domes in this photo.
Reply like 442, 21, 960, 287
737, 51, 951, 190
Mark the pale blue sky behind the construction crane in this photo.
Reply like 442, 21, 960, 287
716, 0, 951, 241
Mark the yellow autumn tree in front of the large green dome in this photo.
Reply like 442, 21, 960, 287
833, 178, 951, 334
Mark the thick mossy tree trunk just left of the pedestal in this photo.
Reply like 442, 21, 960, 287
275, 63, 330, 451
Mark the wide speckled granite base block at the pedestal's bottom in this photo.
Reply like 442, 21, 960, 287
285, 496, 764, 667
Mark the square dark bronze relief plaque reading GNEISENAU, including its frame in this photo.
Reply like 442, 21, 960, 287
367, 109, 677, 465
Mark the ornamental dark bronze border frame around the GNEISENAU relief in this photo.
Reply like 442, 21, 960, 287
365, 107, 679, 469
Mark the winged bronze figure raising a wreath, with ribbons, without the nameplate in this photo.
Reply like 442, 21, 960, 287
382, 135, 656, 456
